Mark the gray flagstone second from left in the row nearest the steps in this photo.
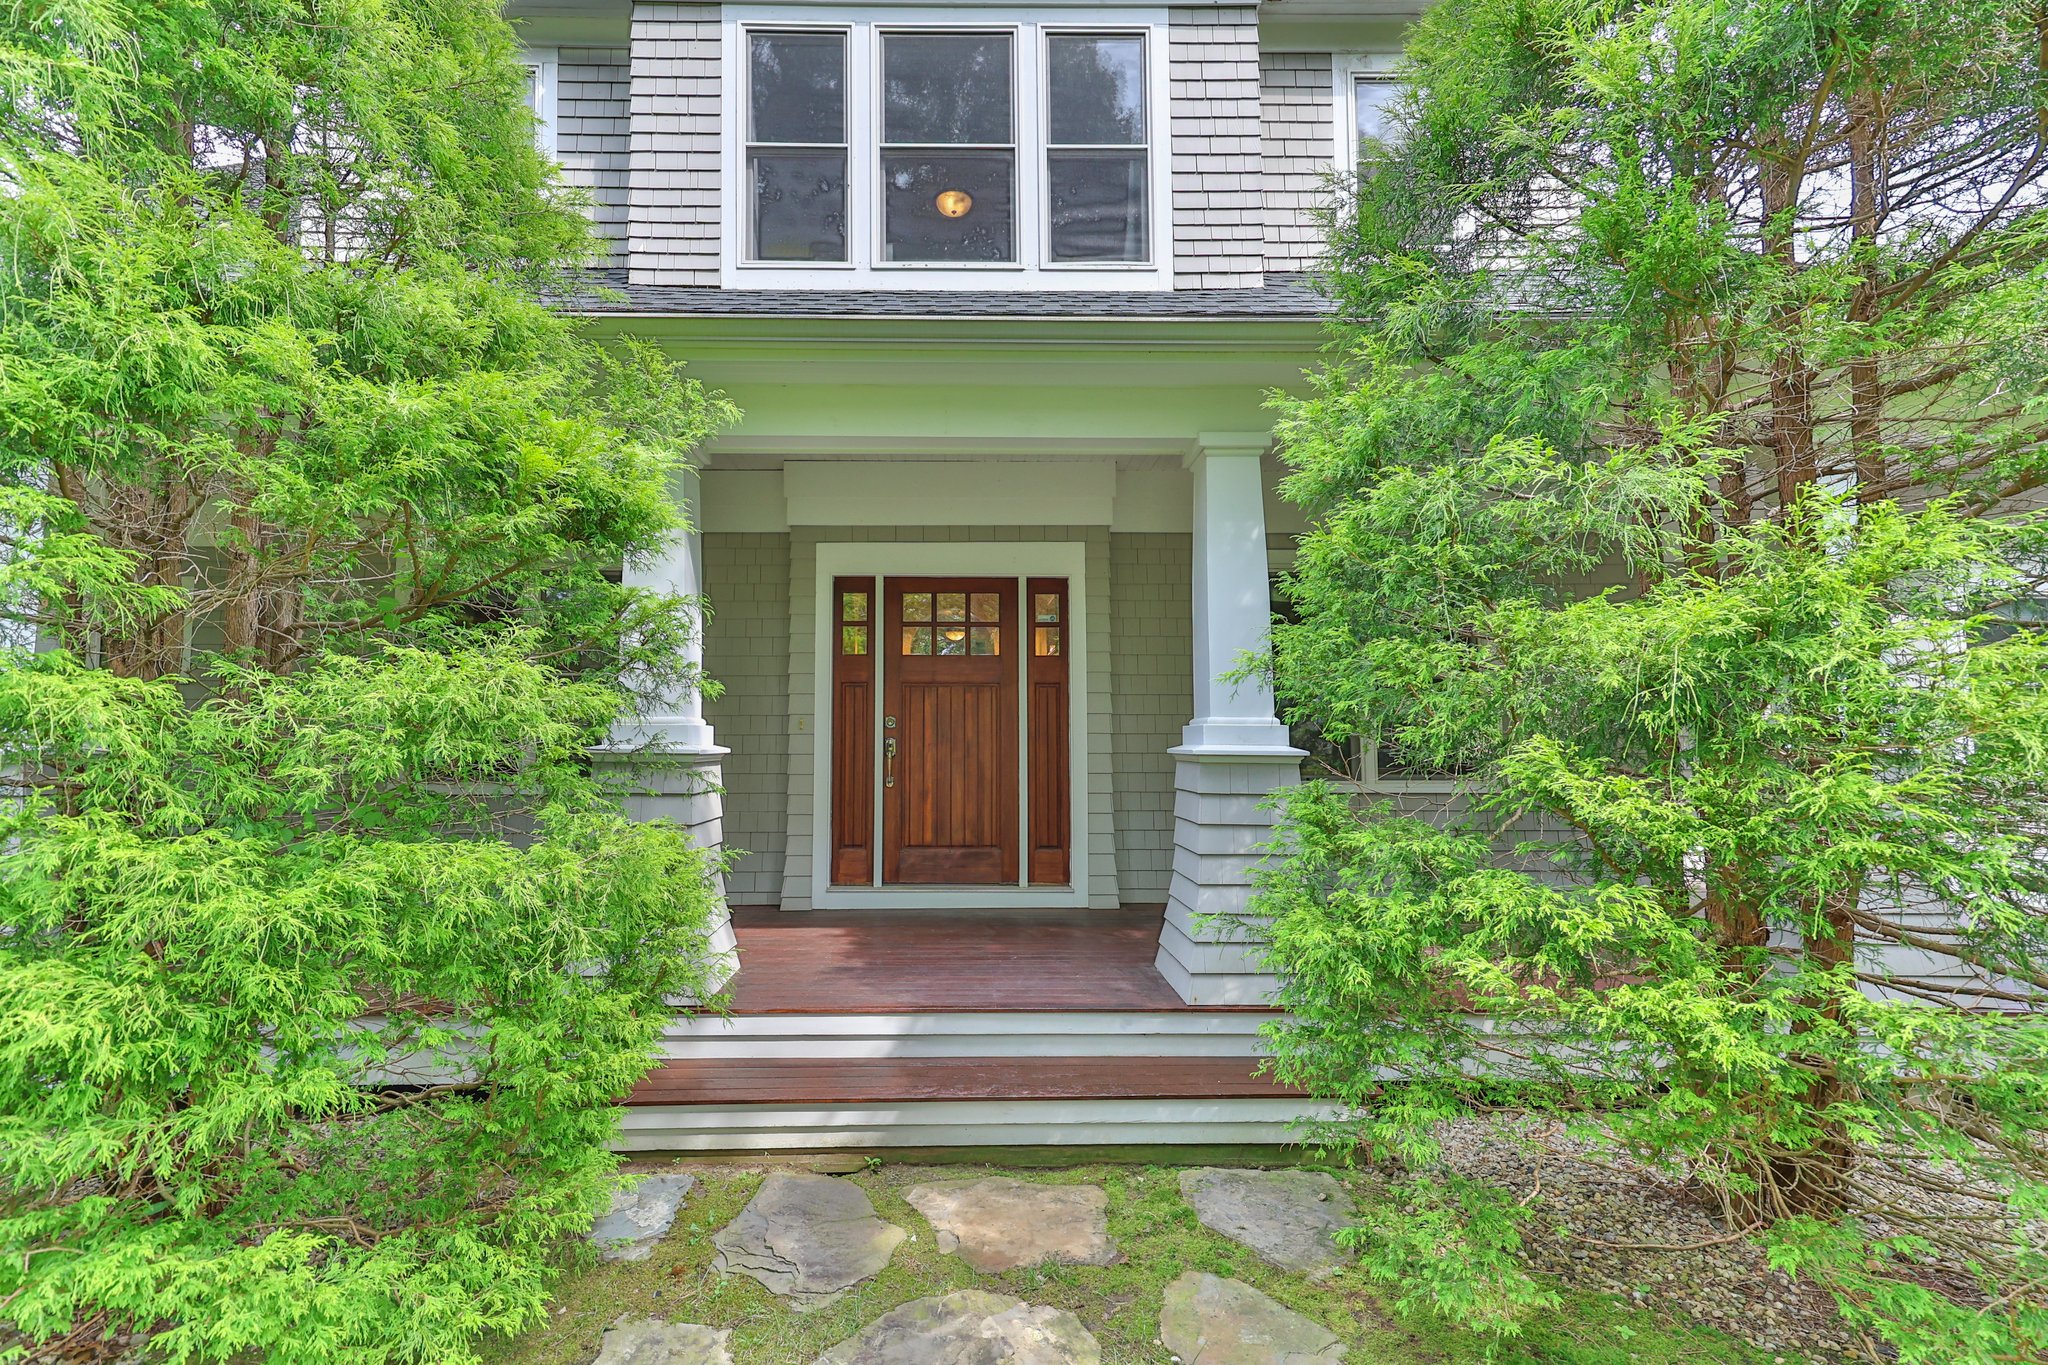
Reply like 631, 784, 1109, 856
711, 1171, 903, 1312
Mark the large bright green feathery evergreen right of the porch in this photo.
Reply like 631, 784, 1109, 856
1262, 0, 2048, 1365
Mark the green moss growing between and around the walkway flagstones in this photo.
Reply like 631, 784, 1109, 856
481, 1162, 1774, 1365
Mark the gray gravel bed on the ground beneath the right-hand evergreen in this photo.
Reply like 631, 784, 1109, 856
1440, 1117, 1870, 1365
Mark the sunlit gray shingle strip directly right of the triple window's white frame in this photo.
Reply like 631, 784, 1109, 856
1167, 6, 1266, 289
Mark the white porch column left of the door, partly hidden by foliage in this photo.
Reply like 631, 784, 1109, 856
608, 469, 739, 984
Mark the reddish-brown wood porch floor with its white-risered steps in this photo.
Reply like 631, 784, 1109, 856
625, 907, 1305, 1150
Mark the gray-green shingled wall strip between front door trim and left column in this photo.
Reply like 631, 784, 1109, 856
705, 532, 791, 905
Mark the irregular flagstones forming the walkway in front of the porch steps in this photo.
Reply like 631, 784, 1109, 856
592, 1169, 1356, 1365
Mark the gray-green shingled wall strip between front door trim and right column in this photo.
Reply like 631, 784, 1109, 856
1110, 532, 1194, 905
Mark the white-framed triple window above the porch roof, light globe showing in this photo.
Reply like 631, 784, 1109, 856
725, 6, 1169, 289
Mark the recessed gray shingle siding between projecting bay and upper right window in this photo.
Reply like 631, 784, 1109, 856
1260, 51, 1335, 270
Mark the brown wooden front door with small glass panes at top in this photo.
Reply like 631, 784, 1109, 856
879, 577, 1022, 884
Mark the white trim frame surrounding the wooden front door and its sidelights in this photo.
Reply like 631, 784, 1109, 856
811, 540, 1090, 911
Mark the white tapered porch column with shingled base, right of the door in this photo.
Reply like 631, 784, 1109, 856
1155, 432, 1303, 1005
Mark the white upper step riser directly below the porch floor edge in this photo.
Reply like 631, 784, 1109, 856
662, 1011, 1278, 1062
